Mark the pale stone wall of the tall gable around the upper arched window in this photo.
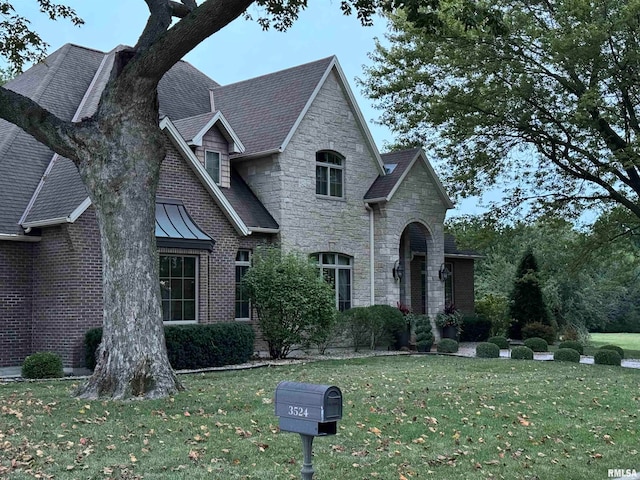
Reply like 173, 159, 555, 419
274, 71, 380, 306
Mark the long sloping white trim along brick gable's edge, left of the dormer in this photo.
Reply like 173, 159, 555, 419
160, 117, 251, 236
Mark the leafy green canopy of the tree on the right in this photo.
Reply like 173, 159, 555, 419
363, 0, 640, 221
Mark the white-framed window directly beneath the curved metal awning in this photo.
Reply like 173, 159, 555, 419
160, 255, 197, 322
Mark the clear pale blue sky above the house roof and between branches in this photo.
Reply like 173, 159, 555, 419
10, 0, 483, 216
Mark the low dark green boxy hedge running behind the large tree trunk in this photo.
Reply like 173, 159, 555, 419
85, 323, 255, 370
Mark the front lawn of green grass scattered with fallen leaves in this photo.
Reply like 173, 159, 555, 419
0, 355, 640, 480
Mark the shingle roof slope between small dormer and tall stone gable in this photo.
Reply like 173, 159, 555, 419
213, 57, 335, 155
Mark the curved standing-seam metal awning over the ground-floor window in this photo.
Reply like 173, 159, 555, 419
156, 197, 216, 250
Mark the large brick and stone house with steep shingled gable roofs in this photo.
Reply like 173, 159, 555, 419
0, 45, 473, 367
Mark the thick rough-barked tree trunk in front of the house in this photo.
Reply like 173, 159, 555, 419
76, 77, 182, 399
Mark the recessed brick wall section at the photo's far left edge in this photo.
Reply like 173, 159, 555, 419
0, 241, 34, 367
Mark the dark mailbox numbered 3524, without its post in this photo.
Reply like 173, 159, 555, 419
275, 382, 342, 436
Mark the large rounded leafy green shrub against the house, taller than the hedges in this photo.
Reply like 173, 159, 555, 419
242, 246, 336, 358
